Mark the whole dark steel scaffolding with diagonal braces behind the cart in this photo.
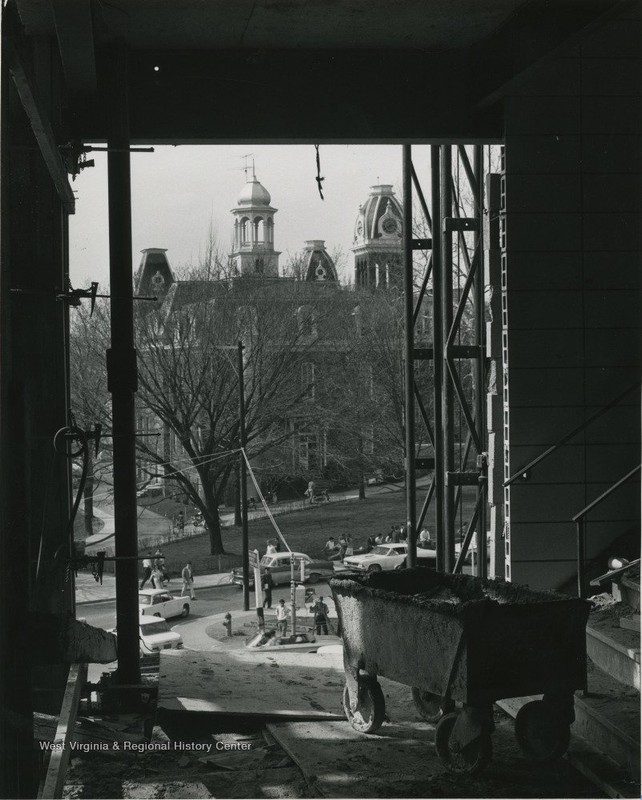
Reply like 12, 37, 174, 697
403, 145, 488, 577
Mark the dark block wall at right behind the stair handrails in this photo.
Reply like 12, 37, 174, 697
502, 6, 642, 587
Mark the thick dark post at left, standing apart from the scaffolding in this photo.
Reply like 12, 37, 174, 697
107, 46, 140, 684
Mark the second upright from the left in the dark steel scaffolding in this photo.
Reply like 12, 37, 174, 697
430, 145, 446, 572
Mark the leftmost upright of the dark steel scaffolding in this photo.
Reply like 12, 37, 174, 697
403, 144, 417, 567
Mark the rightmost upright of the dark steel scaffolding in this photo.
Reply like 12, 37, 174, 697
473, 145, 488, 578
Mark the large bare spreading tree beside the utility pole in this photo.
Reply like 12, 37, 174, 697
137, 278, 323, 553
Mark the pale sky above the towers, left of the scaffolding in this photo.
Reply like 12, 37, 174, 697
70, 145, 430, 288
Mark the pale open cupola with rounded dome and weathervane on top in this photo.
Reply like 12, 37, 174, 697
230, 165, 280, 278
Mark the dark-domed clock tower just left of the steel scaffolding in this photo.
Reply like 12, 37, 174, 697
352, 184, 403, 288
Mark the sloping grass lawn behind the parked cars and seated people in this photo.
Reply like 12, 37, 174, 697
158, 490, 474, 575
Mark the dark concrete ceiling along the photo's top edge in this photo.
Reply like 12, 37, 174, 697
17, 0, 528, 51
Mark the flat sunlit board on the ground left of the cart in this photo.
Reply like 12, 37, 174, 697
158, 650, 344, 719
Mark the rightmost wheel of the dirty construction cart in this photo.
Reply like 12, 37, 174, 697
515, 700, 571, 762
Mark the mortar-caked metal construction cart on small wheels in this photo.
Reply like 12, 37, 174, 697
330, 568, 591, 774
